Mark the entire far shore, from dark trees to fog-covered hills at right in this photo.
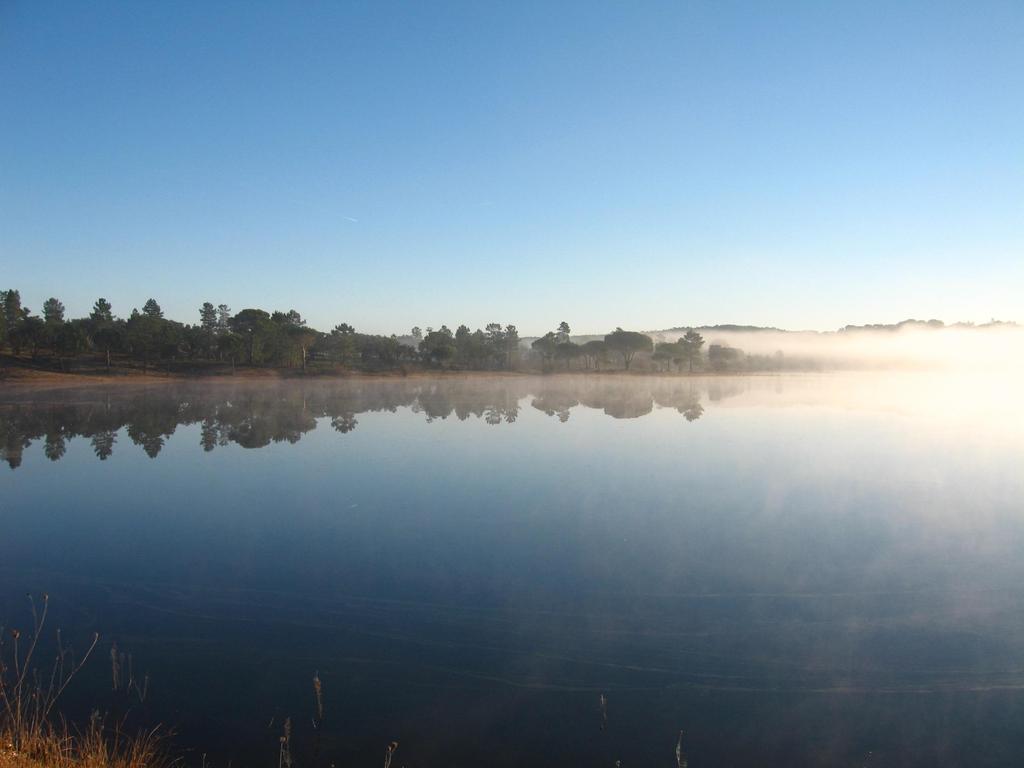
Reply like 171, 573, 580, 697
0, 289, 1022, 374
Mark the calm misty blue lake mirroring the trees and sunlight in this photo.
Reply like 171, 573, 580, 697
0, 373, 1024, 768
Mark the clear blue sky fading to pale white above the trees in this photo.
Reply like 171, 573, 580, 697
0, 0, 1024, 333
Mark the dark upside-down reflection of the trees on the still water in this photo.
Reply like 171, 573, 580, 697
0, 377, 729, 469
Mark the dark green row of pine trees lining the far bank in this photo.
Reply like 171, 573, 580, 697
0, 289, 738, 372
